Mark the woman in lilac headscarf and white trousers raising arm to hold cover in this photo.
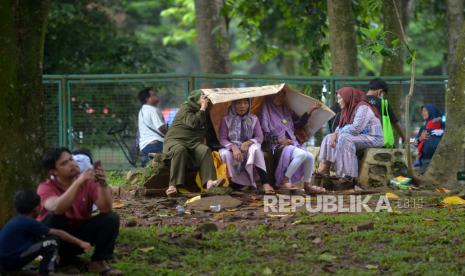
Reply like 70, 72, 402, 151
259, 91, 325, 194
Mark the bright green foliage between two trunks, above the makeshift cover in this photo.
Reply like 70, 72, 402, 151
223, 0, 329, 74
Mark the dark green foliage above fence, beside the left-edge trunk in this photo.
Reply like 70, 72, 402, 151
44, 0, 173, 74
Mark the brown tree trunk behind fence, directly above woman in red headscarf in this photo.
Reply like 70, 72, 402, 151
328, 0, 358, 76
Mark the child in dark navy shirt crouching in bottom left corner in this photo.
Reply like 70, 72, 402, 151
0, 191, 92, 275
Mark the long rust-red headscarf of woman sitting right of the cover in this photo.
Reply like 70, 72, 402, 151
337, 87, 381, 128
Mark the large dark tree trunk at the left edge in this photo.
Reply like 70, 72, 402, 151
0, 0, 48, 225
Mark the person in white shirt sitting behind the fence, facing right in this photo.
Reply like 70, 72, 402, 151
138, 88, 168, 166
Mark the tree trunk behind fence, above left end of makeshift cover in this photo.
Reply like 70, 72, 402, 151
195, 0, 231, 74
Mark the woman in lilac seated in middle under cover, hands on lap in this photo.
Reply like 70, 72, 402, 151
219, 99, 274, 194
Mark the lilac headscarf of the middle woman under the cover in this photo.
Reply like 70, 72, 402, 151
225, 98, 257, 145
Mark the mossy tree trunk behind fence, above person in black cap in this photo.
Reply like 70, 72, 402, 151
381, 0, 409, 143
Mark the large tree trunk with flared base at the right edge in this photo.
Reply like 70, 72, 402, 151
425, 7, 465, 188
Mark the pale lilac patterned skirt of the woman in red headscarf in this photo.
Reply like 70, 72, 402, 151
319, 133, 384, 177
